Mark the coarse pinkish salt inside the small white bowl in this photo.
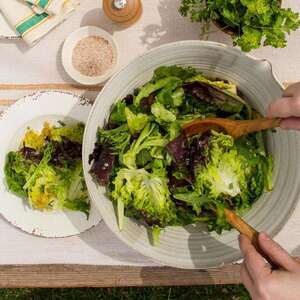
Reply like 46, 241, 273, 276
72, 36, 114, 77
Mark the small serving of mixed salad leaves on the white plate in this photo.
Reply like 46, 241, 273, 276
5, 122, 90, 216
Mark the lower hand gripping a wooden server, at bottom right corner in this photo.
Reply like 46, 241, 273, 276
239, 233, 300, 300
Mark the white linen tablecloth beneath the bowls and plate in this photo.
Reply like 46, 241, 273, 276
0, 0, 300, 266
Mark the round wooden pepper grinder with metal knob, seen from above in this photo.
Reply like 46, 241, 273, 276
103, 0, 143, 26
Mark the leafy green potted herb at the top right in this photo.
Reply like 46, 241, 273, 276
179, 0, 300, 52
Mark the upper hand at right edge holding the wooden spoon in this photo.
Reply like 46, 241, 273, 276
268, 82, 300, 130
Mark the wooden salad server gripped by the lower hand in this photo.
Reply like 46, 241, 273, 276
224, 208, 279, 269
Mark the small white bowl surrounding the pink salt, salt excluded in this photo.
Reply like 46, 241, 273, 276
62, 26, 118, 85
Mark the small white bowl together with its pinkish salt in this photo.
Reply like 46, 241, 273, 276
62, 26, 118, 85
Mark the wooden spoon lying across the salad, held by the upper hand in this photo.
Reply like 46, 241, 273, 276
183, 118, 281, 139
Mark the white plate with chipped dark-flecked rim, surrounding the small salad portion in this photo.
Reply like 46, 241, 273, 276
0, 92, 101, 237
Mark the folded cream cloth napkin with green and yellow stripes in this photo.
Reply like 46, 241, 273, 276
0, 0, 79, 46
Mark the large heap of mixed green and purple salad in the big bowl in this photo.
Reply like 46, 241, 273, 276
90, 66, 273, 244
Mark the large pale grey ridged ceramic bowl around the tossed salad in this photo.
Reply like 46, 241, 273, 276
83, 41, 300, 268
